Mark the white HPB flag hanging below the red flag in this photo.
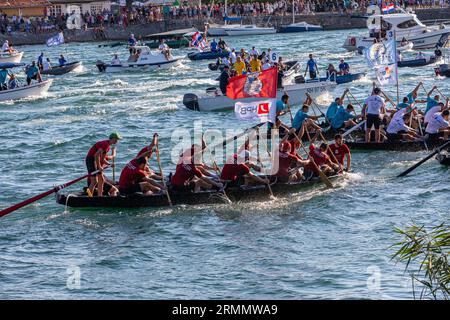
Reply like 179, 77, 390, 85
234, 99, 277, 123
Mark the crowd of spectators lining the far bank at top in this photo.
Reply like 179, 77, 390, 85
0, 0, 450, 34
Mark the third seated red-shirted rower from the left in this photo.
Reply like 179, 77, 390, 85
220, 150, 268, 186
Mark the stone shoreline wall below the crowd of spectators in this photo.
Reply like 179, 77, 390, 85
0, 8, 450, 46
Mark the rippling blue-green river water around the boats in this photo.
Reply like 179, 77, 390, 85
0, 30, 450, 299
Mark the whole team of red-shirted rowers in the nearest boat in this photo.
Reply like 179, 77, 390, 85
86, 128, 351, 196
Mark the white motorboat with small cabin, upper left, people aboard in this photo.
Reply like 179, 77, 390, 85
96, 46, 180, 72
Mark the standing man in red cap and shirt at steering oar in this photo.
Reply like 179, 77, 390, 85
86, 132, 121, 196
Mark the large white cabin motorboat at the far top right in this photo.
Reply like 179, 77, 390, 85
343, 12, 450, 51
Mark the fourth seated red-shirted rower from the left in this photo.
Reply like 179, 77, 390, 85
272, 129, 310, 183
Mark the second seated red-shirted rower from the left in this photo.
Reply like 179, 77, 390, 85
171, 145, 223, 192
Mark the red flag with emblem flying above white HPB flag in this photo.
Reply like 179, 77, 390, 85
227, 67, 278, 100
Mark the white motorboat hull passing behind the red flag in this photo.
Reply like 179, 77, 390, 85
183, 81, 336, 111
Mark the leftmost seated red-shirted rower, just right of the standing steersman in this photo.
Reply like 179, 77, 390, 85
119, 157, 162, 195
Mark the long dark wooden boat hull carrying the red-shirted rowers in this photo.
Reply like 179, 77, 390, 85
56, 174, 342, 208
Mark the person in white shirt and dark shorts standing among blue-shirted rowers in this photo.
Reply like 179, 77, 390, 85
363, 88, 386, 143
